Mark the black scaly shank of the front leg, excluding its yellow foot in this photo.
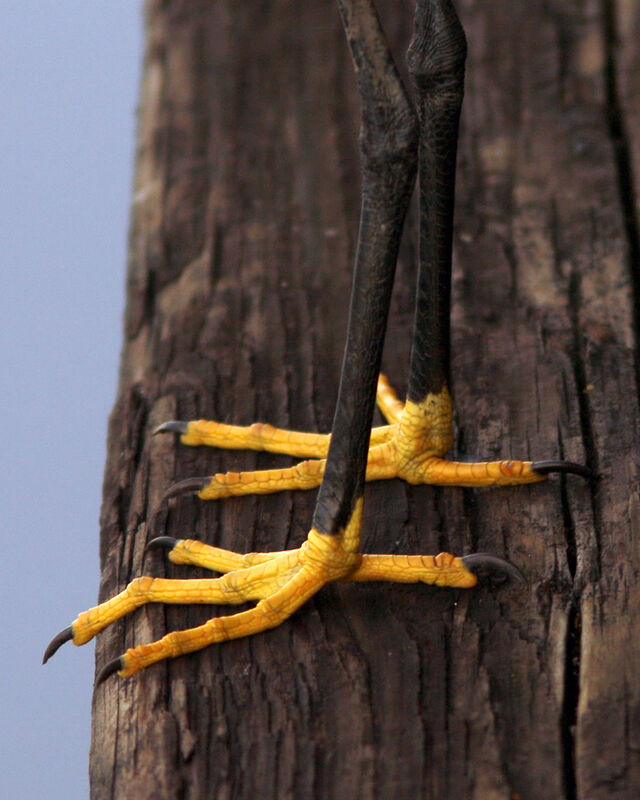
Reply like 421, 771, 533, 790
313, 0, 418, 533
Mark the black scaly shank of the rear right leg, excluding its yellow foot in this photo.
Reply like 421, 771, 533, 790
407, 2, 467, 403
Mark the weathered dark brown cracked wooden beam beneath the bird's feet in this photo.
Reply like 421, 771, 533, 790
91, 0, 640, 800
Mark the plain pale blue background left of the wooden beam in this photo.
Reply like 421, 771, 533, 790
0, 0, 142, 800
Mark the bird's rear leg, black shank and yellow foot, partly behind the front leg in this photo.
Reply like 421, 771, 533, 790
152, 0, 590, 500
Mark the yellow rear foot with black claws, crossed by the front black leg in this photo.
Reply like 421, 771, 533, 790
154, 375, 593, 500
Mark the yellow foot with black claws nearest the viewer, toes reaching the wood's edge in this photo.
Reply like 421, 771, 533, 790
43, 503, 524, 684
